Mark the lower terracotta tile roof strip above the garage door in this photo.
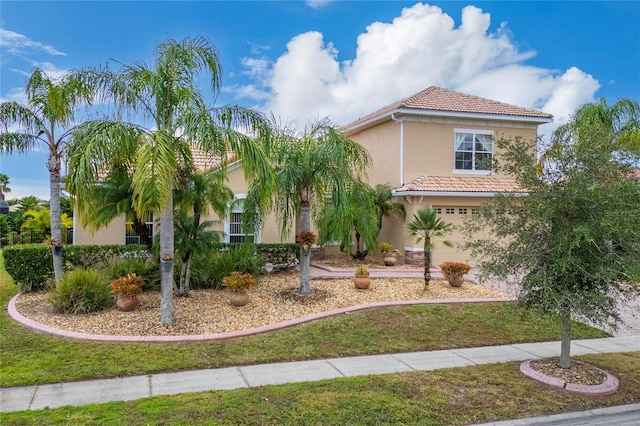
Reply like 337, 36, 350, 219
394, 176, 522, 195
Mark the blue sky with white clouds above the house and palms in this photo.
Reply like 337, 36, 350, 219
0, 0, 640, 199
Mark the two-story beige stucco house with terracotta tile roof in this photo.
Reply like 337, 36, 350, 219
74, 87, 552, 264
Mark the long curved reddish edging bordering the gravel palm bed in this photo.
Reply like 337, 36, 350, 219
7, 293, 514, 343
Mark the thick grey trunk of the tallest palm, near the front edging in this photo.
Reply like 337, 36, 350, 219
160, 194, 176, 324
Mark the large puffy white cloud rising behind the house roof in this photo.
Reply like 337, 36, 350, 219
235, 3, 599, 133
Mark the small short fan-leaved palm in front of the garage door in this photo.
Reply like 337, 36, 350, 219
407, 207, 453, 290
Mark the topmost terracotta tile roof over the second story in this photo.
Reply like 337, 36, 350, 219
343, 86, 553, 130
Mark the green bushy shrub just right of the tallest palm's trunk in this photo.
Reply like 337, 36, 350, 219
191, 243, 264, 289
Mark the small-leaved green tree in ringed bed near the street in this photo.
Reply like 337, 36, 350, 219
465, 103, 640, 368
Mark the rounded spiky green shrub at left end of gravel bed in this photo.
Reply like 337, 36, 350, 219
48, 269, 113, 314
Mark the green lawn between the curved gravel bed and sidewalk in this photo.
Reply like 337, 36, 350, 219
0, 251, 608, 386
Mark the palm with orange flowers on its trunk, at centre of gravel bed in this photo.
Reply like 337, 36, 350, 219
245, 119, 371, 294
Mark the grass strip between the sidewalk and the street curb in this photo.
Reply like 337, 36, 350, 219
1, 352, 640, 425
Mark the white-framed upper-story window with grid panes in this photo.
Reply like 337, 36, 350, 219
455, 129, 493, 172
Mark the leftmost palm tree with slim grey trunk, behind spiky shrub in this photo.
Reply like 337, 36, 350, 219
0, 68, 95, 281
